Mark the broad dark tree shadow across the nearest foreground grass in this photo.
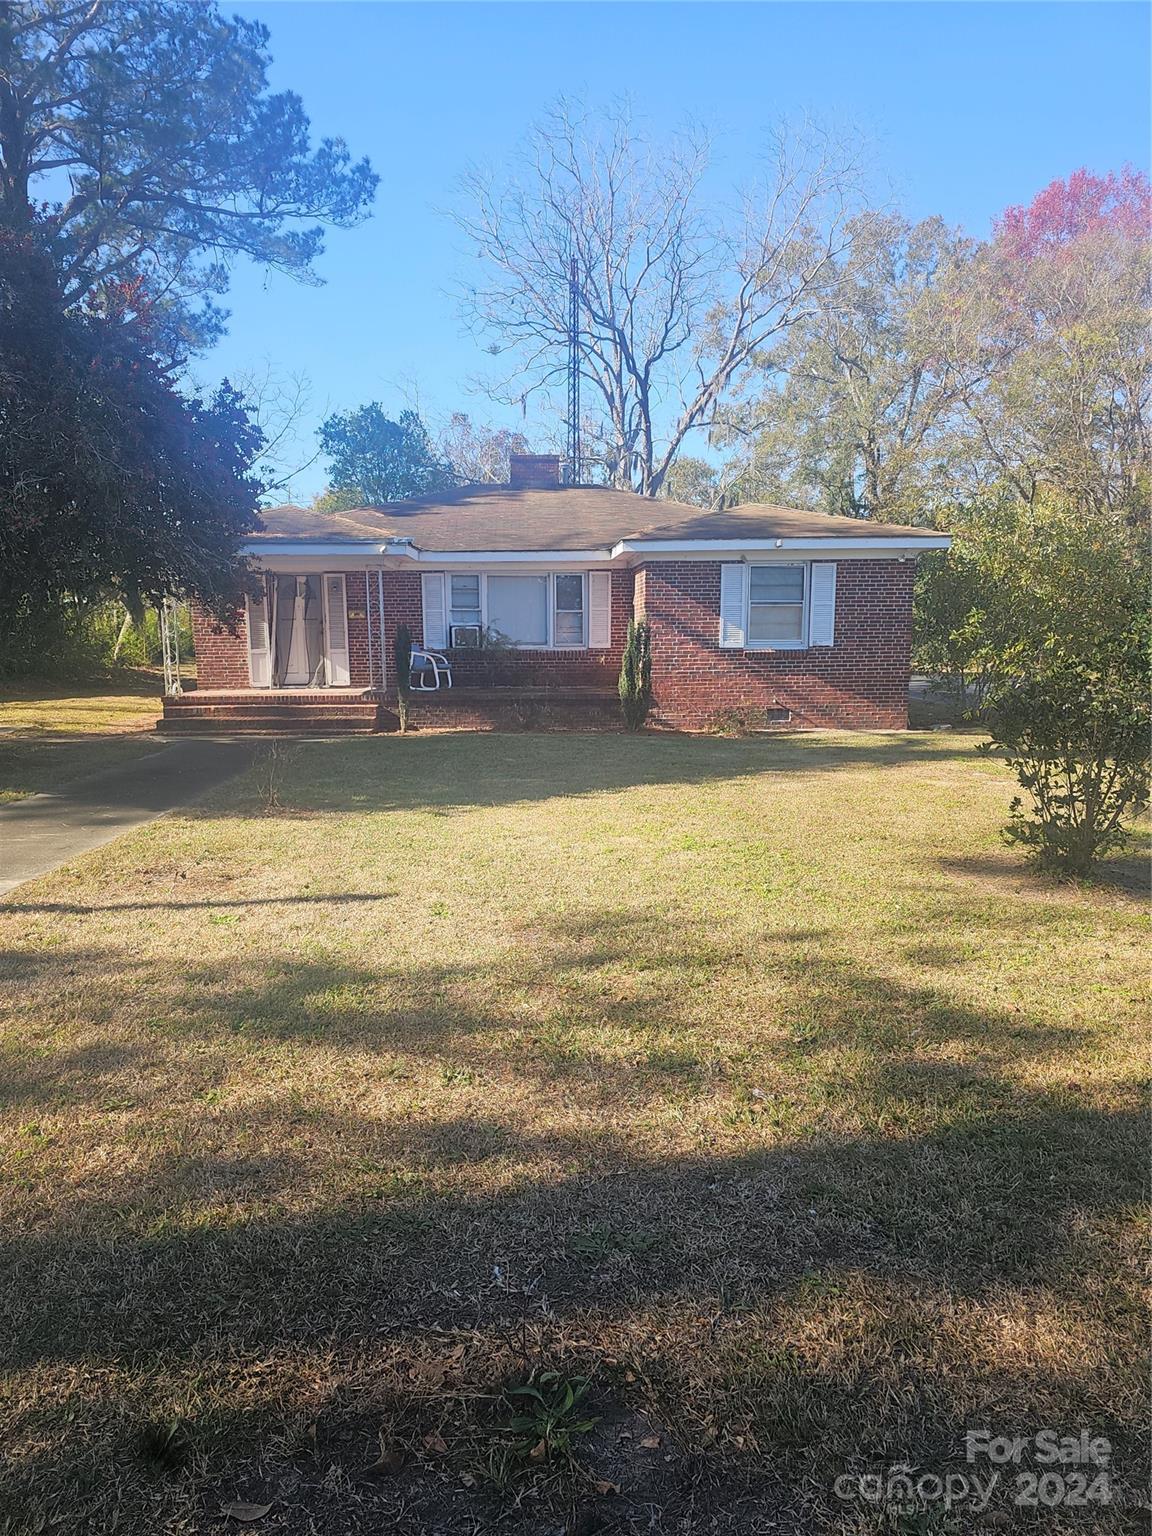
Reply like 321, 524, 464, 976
0, 1091, 1146, 1536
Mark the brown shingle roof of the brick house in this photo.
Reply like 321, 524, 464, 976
253, 485, 938, 553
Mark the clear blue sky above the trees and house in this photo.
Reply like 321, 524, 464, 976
195, 0, 1150, 499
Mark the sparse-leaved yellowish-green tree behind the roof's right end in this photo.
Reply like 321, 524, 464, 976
719, 212, 974, 522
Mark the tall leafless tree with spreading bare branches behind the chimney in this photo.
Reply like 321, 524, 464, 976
458, 103, 854, 496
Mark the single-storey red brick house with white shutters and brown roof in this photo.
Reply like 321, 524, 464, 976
166, 455, 948, 730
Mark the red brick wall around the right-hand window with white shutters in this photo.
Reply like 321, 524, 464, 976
636, 559, 915, 730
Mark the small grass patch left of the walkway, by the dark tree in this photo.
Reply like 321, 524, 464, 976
0, 670, 167, 805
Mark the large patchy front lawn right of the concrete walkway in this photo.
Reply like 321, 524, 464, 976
0, 734, 1149, 1536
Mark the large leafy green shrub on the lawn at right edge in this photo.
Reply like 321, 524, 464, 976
920, 492, 1150, 876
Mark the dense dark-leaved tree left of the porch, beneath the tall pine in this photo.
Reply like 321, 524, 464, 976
0, 232, 260, 633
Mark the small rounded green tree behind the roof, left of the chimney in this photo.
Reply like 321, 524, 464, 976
318, 401, 455, 511
